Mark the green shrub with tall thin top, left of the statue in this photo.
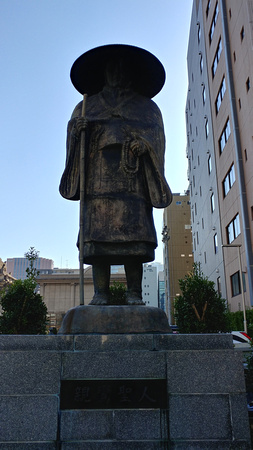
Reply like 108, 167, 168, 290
0, 247, 47, 334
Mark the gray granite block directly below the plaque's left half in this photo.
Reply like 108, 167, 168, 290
60, 410, 113, 441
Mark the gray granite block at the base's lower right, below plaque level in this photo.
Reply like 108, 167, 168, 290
169, 394, 232, 440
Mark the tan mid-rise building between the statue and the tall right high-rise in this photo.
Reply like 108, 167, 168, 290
162, 191, 193, 324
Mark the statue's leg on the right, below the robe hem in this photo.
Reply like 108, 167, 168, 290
125, 258, 145, 305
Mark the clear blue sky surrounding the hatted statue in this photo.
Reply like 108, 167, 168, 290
0, 0, 192, 268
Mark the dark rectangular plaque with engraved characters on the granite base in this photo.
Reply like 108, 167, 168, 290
60, 379, 167, 410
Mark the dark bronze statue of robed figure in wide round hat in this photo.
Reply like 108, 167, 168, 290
60, 45, 172, 305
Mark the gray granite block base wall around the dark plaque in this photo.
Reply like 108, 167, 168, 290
0, 334, 251, 450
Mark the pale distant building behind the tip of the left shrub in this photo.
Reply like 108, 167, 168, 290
7, 257, 54, 280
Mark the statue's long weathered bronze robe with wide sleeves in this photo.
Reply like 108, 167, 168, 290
60, 87, 172, 264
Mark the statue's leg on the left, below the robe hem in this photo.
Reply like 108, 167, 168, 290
89, 260, 110, 305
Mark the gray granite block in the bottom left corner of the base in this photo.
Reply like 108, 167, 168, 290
0, 395, 58, 443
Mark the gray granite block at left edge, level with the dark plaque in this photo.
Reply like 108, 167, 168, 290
0, 351, 61, 395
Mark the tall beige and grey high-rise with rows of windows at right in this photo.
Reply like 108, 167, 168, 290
186, 0, 253, 311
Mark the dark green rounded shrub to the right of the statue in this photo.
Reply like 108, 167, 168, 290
175, 263, 229, 333
